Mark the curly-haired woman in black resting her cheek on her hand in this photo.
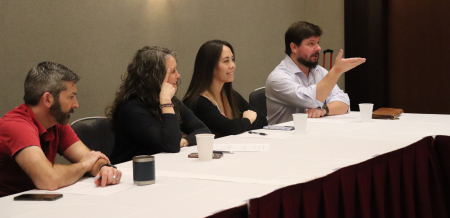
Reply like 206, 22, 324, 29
107, 46, 210, 163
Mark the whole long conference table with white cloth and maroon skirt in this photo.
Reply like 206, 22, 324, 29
0, 112, 450, 218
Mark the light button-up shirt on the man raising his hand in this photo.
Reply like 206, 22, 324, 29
266, 55, 350, 125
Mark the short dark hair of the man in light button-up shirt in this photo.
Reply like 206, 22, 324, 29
284, 21, 322, 56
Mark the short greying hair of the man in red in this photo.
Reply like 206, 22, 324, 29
23, 61, 80, 106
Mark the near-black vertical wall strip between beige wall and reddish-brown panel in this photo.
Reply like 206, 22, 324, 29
344, 0, 389, 111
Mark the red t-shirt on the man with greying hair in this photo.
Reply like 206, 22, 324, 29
0, 104, 80, 197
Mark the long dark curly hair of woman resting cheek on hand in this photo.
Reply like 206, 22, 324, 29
106, 46, 181, 129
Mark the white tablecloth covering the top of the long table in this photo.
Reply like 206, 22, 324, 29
0, 113, 450, 218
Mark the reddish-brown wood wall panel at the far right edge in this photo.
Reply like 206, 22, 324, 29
388, 0, 450, 114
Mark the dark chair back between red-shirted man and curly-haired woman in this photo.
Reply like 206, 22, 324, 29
70, 117, 114, 158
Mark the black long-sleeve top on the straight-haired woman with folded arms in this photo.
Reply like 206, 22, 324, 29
185, 93, 267, 138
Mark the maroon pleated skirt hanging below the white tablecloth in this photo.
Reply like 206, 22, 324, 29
209, 136, 450, 218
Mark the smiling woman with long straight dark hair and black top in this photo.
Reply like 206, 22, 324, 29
183, 40, 267, 137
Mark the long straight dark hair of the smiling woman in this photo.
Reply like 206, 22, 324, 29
183, 39, 242, 118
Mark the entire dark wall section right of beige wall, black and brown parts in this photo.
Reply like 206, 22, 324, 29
344, 0, 450, 114
